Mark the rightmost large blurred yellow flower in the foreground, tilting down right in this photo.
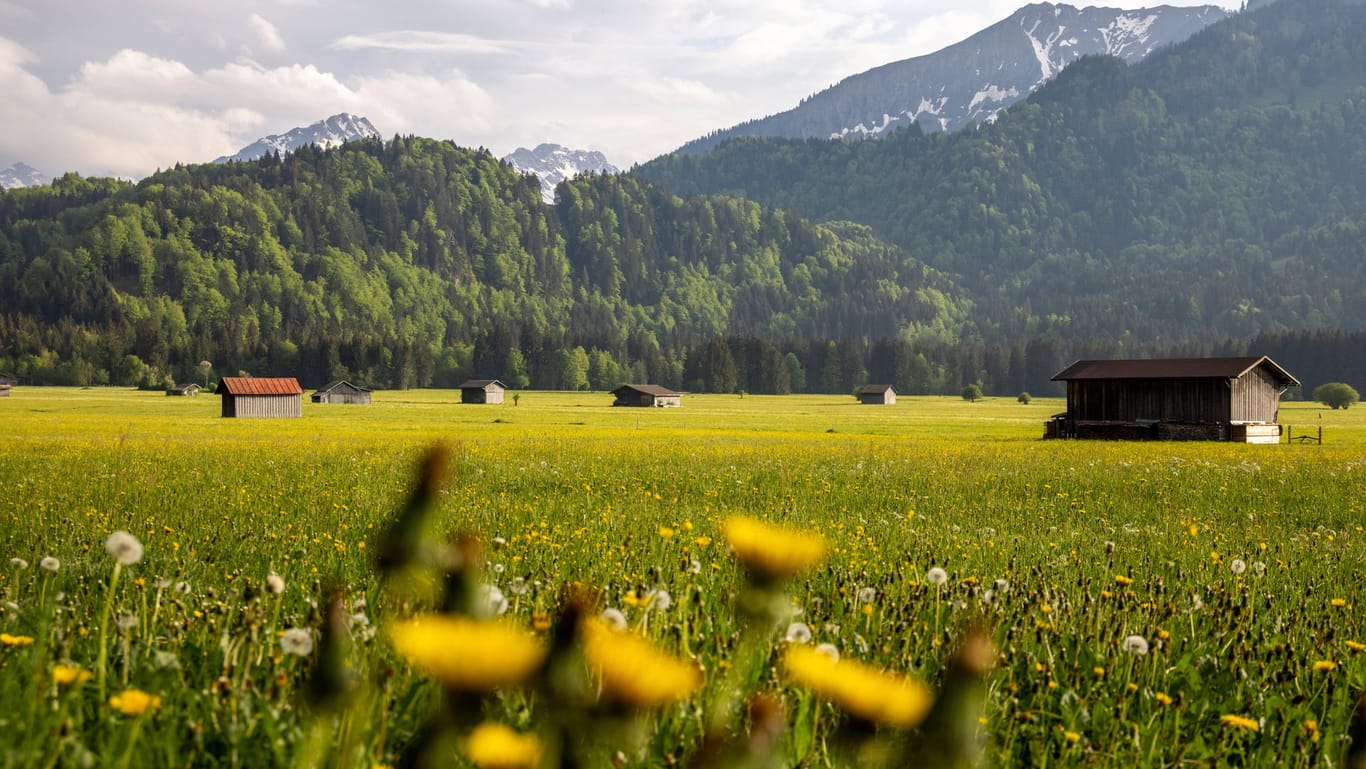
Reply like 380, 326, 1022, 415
783, 645, 933, 728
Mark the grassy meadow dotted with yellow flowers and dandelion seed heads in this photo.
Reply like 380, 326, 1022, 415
0, 388, 1366, 766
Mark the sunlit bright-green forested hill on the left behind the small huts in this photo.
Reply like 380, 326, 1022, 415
0, 138, 971, 392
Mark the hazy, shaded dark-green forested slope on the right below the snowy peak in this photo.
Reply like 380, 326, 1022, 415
634, 0, 1366, 347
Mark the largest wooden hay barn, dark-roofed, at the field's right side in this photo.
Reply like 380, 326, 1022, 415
1045, 355, 1299, 443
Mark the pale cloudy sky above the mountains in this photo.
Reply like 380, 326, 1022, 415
0, 0, 1240, 178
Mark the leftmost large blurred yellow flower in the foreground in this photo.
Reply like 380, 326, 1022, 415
389, 615, 545, 691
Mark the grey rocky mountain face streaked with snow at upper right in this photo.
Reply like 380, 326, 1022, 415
679, 3, 1228, 153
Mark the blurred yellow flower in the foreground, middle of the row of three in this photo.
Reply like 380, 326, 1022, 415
583, 619, 702, 708
